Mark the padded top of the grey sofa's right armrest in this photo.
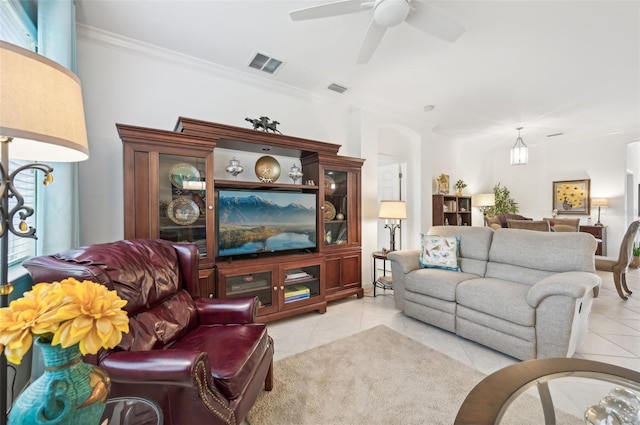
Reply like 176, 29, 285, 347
527, 272, 602, 308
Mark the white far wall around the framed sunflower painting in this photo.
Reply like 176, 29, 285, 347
450, 135, 639, 256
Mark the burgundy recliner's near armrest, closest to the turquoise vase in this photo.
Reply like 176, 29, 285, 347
100, 350, 209, 388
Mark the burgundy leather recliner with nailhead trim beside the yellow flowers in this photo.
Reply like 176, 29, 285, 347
24, 239, 273, 425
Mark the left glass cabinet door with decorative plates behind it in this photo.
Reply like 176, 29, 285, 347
158, 154, 210, 258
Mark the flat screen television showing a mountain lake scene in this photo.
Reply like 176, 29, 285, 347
216, 189, 317, 257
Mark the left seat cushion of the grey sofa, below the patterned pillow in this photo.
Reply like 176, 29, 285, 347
404, 269, 479, 301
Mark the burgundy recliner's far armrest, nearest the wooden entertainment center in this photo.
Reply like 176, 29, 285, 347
194, 297, 259, 325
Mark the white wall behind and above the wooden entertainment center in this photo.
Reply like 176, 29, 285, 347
78, 27, 430, 282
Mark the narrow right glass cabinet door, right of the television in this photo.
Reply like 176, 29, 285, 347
322, 170, 349, 246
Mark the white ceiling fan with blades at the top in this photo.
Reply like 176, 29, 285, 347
289, 0, 465, 64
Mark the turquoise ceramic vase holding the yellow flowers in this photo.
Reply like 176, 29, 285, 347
9, 338, 111, 425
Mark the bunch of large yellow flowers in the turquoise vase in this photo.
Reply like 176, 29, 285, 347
0, 278, 129, 364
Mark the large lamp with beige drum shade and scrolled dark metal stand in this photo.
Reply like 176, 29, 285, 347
0, 41, 89, 425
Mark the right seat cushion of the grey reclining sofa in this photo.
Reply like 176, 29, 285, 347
456, 278, 536, 327
